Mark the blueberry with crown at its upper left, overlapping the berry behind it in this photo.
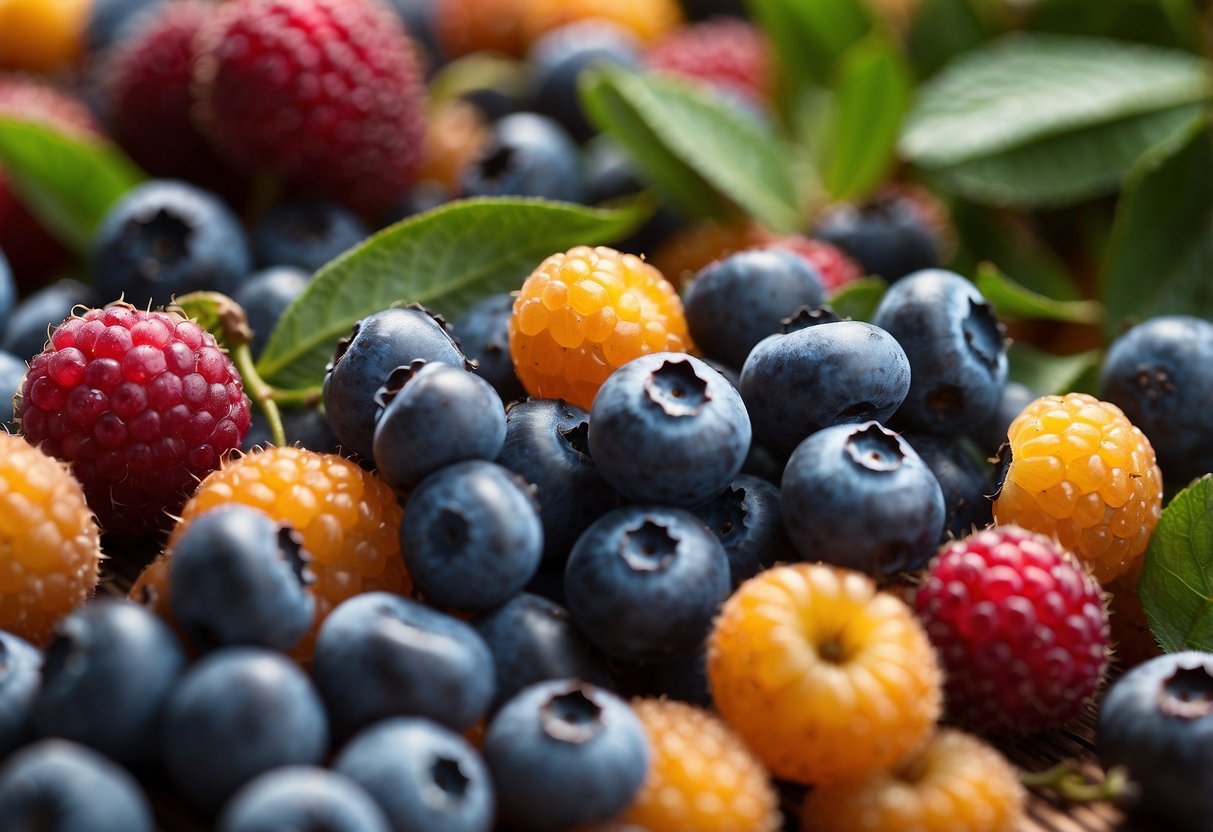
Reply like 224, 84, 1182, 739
371, 359, 506, 490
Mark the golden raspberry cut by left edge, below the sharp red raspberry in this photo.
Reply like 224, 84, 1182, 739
0, 429, 102, 644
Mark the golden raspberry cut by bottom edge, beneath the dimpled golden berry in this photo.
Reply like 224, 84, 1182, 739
801, 730, 1024, 832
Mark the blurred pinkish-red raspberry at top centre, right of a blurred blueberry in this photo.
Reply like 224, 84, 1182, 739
648, 17, 771, 102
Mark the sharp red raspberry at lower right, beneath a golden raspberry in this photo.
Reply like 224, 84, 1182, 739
915, 526, 1110, 731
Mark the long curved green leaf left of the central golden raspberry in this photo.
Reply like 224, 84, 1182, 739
257, 198, 651, 388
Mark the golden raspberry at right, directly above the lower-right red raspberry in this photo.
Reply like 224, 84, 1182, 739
993, 393, 1162, 583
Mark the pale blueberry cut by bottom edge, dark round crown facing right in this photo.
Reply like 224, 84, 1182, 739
334, 717, 496, 832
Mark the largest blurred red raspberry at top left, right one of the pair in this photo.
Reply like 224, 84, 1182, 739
194, 0, 426, 213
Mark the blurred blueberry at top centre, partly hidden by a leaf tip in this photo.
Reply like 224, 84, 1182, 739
526, 18, 640, 142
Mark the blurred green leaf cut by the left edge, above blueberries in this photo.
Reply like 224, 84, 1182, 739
0, 118, 147, 255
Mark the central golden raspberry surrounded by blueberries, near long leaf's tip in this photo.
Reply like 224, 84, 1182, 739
509, 246, 691, 410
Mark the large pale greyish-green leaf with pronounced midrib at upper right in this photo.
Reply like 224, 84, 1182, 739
900, 34, 1209, 207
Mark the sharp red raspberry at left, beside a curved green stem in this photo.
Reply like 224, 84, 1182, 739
17, 303, 249, 532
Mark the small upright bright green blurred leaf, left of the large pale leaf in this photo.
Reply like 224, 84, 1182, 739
825, 36, 911, 201
